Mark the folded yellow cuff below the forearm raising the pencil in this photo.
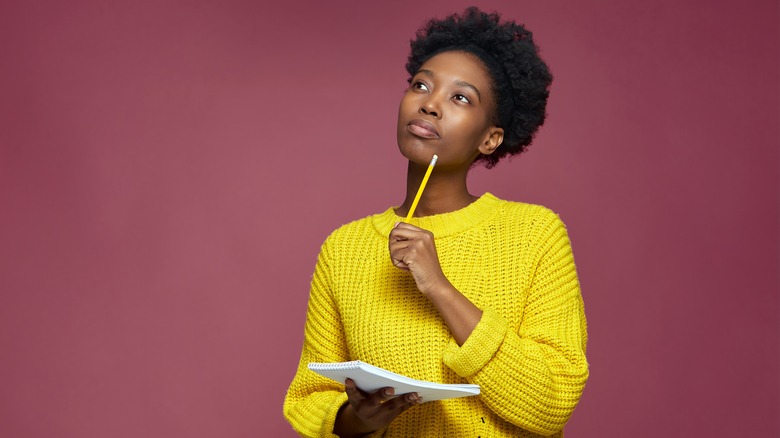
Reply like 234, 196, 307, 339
442, 309, 509, 378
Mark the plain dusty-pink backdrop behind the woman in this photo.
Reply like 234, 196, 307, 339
0, 0, 780, 438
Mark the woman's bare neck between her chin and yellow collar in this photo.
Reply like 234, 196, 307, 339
396, 161, 477, 217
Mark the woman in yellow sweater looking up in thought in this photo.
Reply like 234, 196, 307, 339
284, 8, 588, 437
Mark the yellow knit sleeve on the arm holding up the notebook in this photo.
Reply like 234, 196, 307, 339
284, 241, 349, 437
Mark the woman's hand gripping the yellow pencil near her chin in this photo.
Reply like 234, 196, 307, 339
389, 222, 449, 295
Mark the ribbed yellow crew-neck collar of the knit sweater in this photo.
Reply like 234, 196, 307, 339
371, 193, 504, 238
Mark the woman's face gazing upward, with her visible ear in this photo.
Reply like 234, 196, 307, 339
397, 51, 503, 170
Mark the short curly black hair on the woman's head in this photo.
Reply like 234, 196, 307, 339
406, 6, 552, 169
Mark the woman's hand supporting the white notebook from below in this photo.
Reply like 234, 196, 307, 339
333, 379, 422, 438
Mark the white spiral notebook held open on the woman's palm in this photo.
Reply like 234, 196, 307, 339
309, 360, 479, 403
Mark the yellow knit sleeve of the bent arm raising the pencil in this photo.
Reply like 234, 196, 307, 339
443, 213, 588, 435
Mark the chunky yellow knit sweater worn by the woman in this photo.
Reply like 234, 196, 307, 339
284, 193, 588, 438
